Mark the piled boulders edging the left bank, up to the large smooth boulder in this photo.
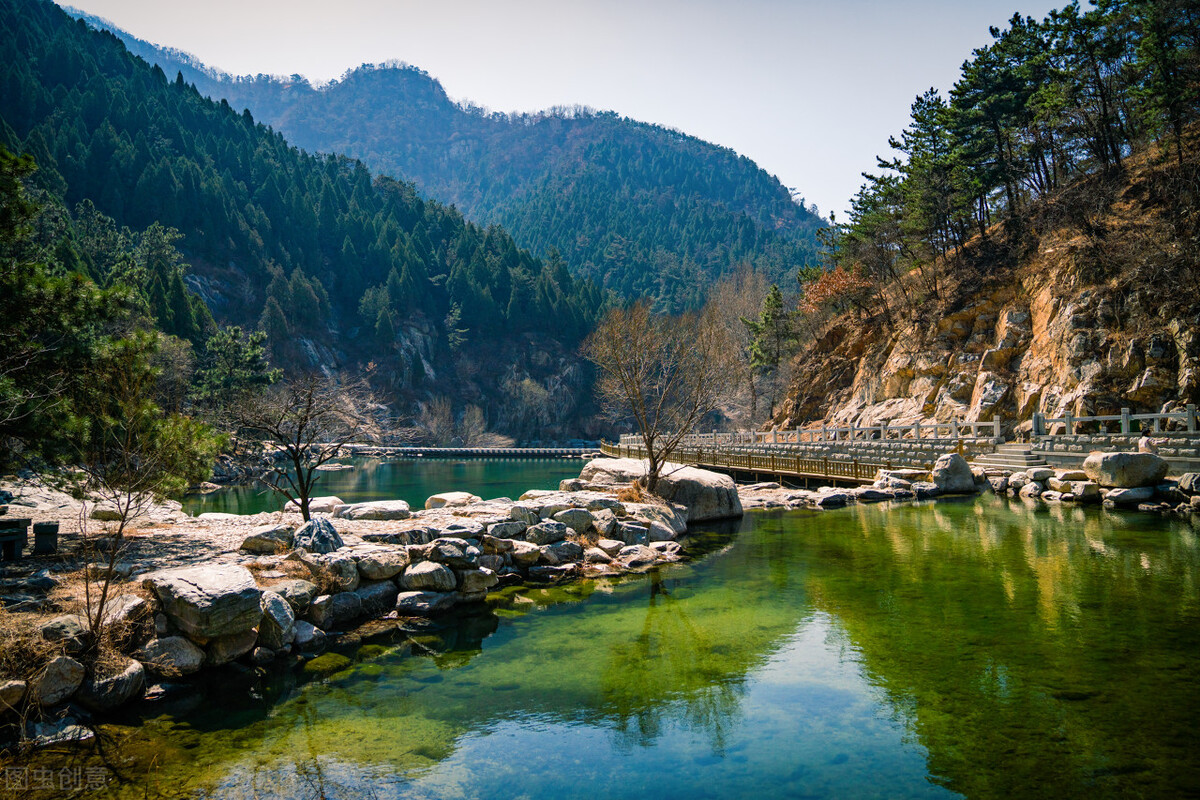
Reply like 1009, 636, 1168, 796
0, 465, 720, 744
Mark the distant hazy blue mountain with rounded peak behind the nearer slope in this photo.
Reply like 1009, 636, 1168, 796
63, 12, 824, 311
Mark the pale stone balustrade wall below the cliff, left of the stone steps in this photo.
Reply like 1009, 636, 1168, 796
619, 420, 1004, 449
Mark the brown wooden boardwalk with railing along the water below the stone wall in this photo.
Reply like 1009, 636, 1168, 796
600, 443, 926, 483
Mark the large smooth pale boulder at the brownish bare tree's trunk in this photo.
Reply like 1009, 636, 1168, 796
580, 458, 742, 522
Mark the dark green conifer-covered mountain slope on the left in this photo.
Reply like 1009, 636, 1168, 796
0, 0, 606, 437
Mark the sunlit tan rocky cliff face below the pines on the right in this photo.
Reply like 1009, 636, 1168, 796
773, 145, 1200, 429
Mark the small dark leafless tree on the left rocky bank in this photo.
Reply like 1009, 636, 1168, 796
235, 373, 379, 522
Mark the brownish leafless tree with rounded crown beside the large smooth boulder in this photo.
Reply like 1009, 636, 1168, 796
583, 302, 737, 493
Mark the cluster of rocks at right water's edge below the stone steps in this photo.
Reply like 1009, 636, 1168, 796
988, 452, 1200, 513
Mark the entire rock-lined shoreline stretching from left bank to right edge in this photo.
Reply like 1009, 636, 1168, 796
0, 453, 1200, 744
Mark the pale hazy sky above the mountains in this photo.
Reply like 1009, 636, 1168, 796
60, 0, 1064, 216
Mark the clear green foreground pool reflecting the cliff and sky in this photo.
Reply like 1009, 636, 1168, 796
28, 497, 1200, 799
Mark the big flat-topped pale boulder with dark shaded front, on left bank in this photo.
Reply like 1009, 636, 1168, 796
145, 564, 263, 639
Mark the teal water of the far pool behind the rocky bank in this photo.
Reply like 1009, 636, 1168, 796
184, 458, 583, 516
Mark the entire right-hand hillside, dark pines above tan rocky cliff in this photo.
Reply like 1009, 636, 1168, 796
774, 0, 1200, 429
